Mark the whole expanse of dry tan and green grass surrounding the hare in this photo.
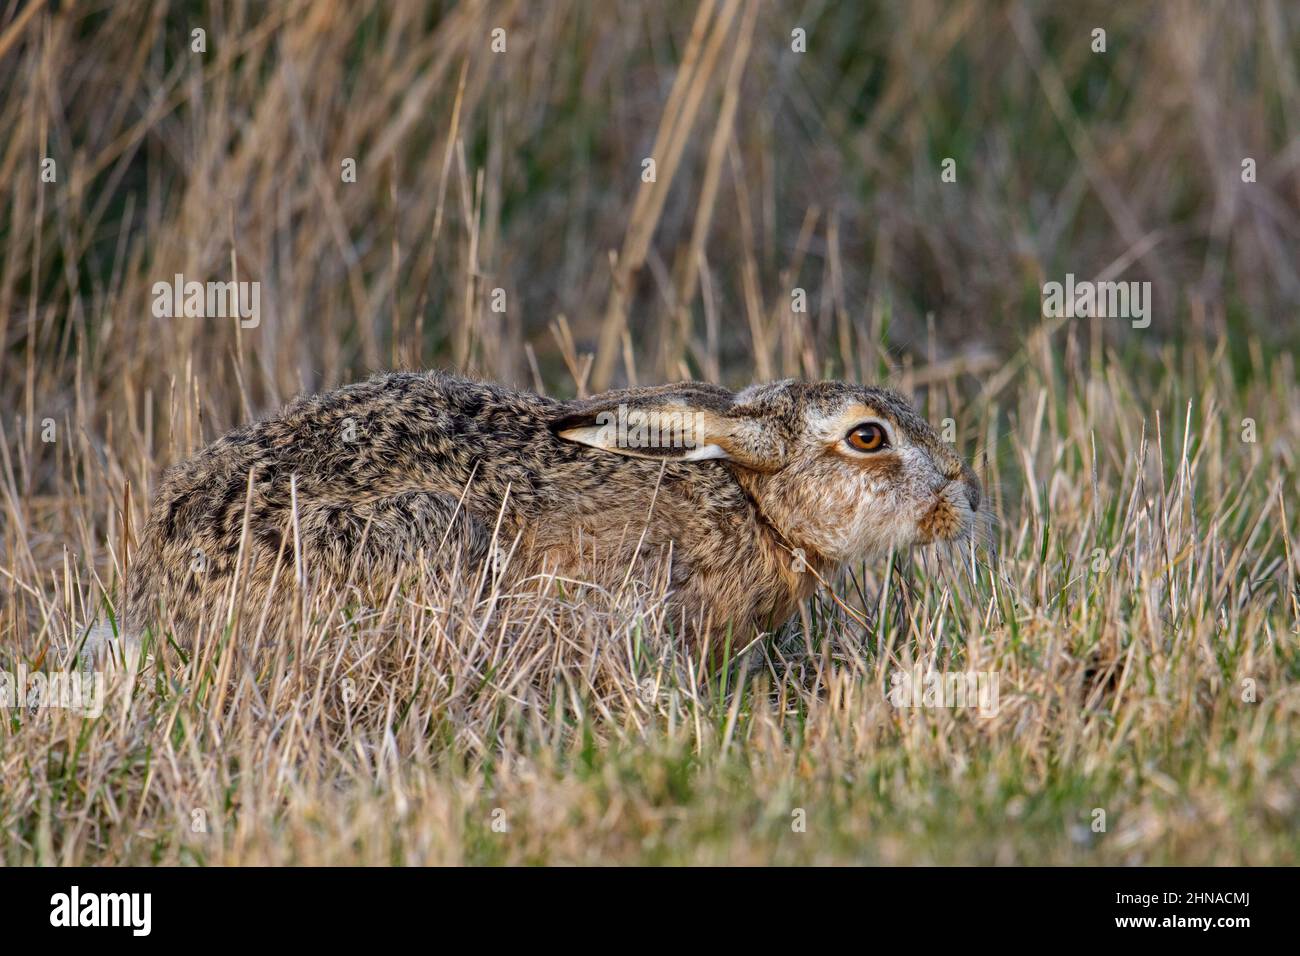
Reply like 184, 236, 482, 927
0, 0, 1300, 864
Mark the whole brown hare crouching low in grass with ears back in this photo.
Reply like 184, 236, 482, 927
126, 372, 980, 655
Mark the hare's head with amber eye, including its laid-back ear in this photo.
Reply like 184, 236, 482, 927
553, 380, 980, 563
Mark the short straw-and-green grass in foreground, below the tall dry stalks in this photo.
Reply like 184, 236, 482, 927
0, 333, 1300, 865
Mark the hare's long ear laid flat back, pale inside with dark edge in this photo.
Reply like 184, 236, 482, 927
550, 385, 783, 471
